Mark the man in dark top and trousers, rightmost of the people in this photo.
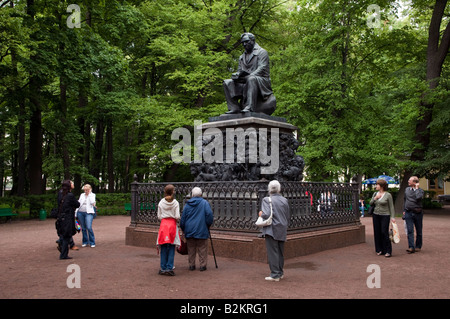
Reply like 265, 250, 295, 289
403, 176, 424, 254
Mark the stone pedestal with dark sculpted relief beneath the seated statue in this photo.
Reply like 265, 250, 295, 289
191, 113, 304, 181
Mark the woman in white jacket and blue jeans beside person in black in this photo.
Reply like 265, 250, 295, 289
76, 184, 95, 247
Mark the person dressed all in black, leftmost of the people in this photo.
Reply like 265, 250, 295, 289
56, 180, 80, 259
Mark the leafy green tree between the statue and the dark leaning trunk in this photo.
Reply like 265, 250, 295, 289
272, 1, 412, 181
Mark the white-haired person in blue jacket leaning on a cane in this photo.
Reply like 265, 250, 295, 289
180, 187, 214, 271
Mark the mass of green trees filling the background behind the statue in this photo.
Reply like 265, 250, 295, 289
0, 0, 450, 195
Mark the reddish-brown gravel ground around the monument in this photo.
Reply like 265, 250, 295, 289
0, 206, 450, 300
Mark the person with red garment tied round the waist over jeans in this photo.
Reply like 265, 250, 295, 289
156, 184, 181, 276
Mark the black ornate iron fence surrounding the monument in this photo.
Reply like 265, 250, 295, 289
130, 182, 360, 233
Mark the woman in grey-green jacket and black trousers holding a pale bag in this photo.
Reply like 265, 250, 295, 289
370, 179, 395, 257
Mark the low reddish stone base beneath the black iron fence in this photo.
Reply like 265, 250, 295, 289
125, 224, 365, 262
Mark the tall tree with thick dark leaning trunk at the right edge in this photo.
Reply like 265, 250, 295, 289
396, 0, 450, 211
